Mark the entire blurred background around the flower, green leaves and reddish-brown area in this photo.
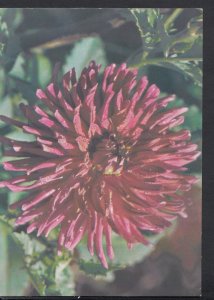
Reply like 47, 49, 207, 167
0, 8, 203, 296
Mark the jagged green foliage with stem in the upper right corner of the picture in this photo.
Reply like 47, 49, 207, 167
129, 8, 202, 86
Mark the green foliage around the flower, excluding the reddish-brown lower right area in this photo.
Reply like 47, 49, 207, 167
0, 8, 203, 296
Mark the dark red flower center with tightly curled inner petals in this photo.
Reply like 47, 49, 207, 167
88, 132, 131, 175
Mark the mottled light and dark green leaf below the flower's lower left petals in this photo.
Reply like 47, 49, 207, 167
14, 232, 74, 296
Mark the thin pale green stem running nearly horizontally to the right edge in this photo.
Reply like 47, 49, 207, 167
131, 57, 202, 68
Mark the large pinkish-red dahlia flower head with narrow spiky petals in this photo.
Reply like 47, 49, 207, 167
0, 62, 199, 268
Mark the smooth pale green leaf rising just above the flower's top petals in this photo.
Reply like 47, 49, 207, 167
63, 37, 107, 76
